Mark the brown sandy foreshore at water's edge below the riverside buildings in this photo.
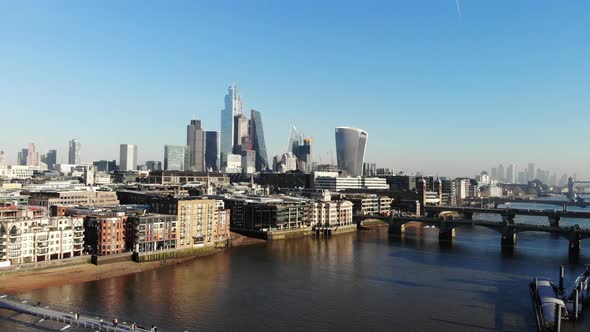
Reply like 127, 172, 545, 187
0, 233, 266, 294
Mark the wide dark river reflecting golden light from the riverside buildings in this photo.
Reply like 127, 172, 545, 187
0, 202, 590, 331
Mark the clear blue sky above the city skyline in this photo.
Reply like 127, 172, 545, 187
0, 0, 590, 177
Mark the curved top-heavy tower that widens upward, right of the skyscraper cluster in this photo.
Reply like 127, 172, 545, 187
336, 127, 369, 176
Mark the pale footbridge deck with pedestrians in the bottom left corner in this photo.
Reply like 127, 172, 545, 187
0, 295, 150, 332
